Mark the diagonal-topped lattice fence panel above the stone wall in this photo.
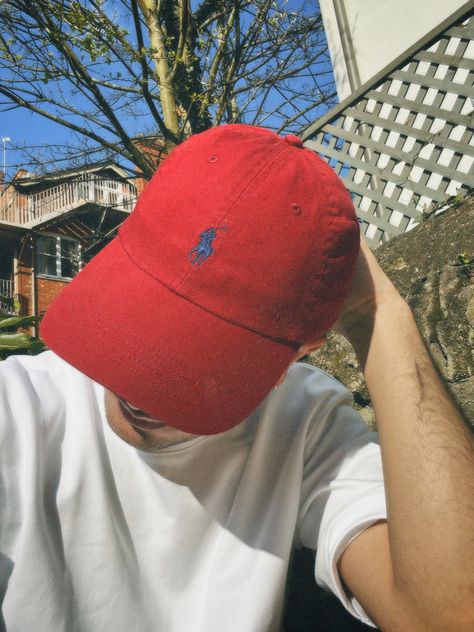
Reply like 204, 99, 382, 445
302, 5, 474, 247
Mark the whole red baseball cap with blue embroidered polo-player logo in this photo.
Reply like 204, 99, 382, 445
40, 125, 359, 435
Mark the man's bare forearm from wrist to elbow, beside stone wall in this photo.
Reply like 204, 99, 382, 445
347, 293, 474, 616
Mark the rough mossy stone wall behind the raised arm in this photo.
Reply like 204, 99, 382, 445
310, 197, 474, 428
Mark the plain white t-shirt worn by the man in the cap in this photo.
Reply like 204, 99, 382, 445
0, 351, 386, 632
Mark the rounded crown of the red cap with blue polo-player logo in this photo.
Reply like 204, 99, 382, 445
119, 125, 359, 346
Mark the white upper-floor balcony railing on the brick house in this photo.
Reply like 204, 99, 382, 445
0, 173, 137, 226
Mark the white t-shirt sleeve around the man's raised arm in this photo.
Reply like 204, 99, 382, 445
296, 376, 387, 627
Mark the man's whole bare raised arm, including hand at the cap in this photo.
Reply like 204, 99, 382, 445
335, 238, 474, 632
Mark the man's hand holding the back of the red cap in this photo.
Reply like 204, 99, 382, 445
332, 235, 403, 340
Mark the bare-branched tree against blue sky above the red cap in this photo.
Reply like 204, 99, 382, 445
0, 0, 335, 177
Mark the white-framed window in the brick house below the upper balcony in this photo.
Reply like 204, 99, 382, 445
38, 235, 81, 279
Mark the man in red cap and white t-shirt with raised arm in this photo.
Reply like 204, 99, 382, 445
0, 125, 474, 632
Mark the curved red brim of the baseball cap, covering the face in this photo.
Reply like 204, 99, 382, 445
40, 237, 296, 435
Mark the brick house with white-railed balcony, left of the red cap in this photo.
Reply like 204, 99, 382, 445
0, 162, 137, 328
